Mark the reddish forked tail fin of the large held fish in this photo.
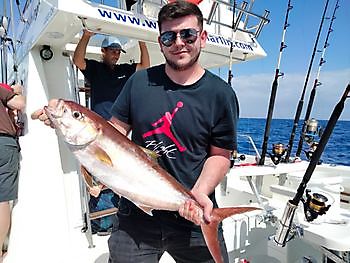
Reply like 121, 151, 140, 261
201, 207, 260, 263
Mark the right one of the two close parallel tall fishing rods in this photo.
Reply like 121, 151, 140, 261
295, 0, 339, 157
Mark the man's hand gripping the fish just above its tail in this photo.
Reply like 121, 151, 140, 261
179, 191, 213, 225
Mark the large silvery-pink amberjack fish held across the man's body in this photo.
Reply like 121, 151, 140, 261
44, 100, 258, 263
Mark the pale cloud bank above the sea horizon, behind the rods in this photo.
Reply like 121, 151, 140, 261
232, 68, 350, 120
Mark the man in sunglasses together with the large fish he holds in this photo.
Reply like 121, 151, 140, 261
32, 1, 252, 263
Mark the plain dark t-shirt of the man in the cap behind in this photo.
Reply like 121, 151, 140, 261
81, 59, 136, 109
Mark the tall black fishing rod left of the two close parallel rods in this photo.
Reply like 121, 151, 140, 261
259, 0, 293, 165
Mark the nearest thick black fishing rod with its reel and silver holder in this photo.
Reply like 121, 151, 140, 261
274, 83, 350, 247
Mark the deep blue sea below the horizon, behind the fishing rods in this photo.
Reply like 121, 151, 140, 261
238, 118, 350, 165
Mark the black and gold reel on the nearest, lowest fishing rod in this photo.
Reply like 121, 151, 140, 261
301, 189, 331, 222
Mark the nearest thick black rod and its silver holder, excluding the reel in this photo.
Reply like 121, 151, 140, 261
274, 83, 350, 247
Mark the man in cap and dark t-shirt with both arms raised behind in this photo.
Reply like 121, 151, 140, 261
73, 29, 150, 120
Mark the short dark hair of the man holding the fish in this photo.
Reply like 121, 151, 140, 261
158, 0, 203, 32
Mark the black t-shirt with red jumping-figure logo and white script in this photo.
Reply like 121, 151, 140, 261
111, 65, 238, 194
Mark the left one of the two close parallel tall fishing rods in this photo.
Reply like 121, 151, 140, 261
285, 0, 329, 162
